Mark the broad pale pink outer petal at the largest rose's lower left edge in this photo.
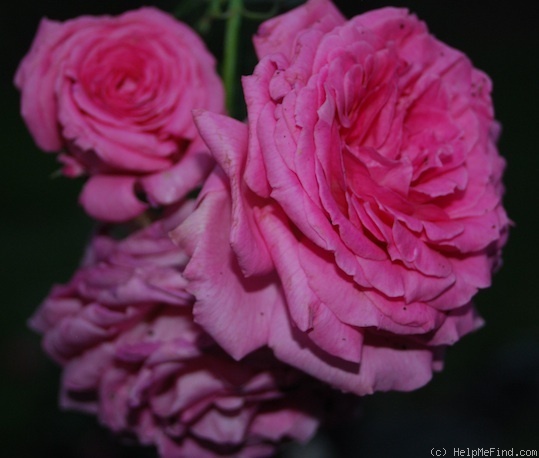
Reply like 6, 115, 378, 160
171, 175, 283, 359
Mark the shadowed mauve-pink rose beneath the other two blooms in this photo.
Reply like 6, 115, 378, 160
31, 204, 341, 458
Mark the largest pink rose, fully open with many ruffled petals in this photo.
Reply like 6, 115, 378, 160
174, 0, 508, 395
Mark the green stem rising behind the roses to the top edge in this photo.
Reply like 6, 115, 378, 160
223, 0, 243, 116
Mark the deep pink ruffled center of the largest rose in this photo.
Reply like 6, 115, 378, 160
320, 50, 467, 233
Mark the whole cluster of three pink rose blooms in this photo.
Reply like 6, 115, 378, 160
15, 0, 510, 457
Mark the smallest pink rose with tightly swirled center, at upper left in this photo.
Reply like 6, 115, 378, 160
15, 8, 224, 221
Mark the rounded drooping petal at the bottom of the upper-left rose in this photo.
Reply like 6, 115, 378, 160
79, 175, 148, 223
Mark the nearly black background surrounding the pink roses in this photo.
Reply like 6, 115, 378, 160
0, 0, 539, 458
